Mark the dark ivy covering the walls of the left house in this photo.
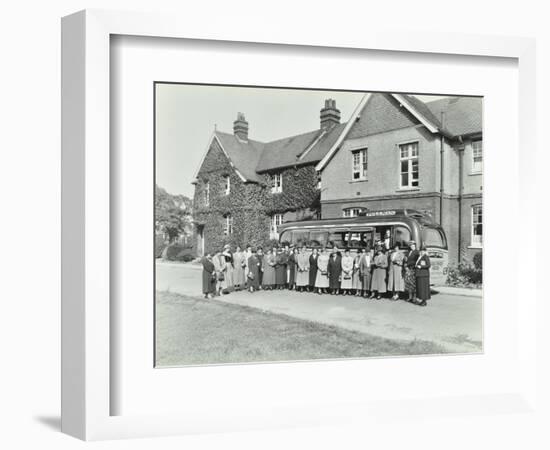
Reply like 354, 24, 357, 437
193, 141, 320, 254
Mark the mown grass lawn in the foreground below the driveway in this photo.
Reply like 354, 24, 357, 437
156, 292, 446, 366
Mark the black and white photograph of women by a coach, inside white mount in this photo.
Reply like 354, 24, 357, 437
154, 82, 483, 367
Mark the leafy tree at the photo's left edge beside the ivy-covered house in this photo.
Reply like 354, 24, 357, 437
155, 186, 192, 242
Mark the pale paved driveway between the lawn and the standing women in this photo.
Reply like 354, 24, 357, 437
156, 263, 482, 353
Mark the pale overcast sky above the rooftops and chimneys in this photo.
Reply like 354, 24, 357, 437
156, 84, 448, 198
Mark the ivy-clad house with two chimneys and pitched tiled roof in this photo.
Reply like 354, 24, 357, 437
193, 99, 346, 255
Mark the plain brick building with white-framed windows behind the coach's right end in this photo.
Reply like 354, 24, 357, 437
316, 94, 483, 262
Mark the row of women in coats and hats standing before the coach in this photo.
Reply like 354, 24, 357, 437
202, 241, 436, 306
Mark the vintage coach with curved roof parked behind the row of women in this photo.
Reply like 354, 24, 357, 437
278, 209, 448, 284
